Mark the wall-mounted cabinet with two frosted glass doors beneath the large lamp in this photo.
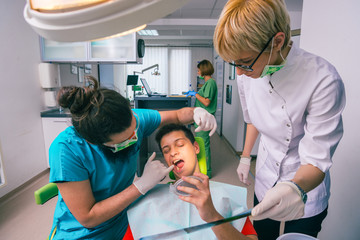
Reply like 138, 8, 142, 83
40, 33, 144, 63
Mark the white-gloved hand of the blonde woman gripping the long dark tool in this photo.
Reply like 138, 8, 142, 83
251, 182, 305, 221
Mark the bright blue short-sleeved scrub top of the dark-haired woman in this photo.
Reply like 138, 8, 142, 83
49, 109, 161, 239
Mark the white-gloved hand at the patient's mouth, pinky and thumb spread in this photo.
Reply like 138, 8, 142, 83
134, 152, 174, 195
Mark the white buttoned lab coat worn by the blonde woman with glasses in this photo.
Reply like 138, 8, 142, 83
237, 46, 345, 217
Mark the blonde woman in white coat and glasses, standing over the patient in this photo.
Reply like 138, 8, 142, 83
214, 0, 345, 240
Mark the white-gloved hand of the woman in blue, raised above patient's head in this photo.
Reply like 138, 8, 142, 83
194, 107, 217, 137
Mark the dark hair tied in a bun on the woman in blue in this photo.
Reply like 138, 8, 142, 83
57, 76, 132, 145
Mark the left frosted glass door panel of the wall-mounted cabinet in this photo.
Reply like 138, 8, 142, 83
42, 39, 87, 61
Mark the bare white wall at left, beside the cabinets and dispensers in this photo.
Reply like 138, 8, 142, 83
0, 0, 46, 197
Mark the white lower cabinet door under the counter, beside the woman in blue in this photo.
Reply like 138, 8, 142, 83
42, 118, 71, 167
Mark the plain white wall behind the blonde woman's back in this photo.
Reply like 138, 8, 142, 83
300, 0, 360, 240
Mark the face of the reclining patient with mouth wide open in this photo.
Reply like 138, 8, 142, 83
160, 131, 200, 178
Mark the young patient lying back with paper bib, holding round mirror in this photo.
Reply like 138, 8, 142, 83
128, 124, 258, 240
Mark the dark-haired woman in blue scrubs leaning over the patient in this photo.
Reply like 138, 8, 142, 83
49, 78, 216, 240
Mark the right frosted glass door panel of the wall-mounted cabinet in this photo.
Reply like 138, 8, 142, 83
90, 34, 136, 61
